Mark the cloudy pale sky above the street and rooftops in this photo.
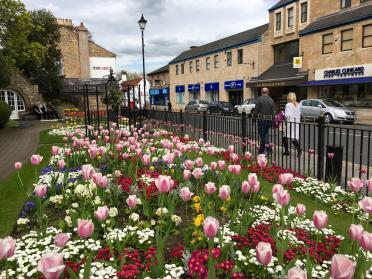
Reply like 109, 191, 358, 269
23, 0, 278, 73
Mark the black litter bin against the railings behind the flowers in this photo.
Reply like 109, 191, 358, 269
325, 145, 344, 185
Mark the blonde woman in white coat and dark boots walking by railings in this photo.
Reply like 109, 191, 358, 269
283, 92, 302, 156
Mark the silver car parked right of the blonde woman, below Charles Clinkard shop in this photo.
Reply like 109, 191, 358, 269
300, 99, 356, 123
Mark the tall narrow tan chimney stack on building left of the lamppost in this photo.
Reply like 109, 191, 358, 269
77, 22, 90, 80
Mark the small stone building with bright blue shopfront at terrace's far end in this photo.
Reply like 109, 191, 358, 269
147, 65, 170, 109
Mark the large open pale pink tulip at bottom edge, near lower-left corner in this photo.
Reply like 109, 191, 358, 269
37, 252, 65, 279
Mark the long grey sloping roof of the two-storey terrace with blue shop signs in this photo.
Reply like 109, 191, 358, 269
169, 24, 269, 64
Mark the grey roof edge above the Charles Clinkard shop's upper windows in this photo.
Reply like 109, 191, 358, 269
300, 3, 372, 36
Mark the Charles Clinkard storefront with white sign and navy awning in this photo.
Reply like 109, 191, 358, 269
302, 64, 372, 108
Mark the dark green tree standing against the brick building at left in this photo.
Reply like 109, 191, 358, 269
18, 9, 62, 100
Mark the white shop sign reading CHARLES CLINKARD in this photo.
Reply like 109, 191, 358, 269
315, 64, 372, 80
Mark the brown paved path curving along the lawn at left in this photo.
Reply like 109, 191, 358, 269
0, 120, 51, 181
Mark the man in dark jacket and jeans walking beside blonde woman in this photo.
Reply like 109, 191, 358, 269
254, 88, 275, 156
